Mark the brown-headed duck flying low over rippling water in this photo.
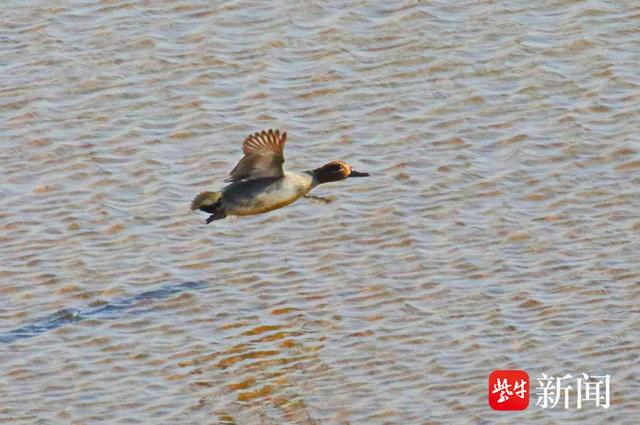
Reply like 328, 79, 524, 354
191, 129, 369, 224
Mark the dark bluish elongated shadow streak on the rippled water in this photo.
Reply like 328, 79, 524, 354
0, 282, 206, 344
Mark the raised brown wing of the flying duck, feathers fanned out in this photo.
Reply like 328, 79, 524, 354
226, 130, 287, 182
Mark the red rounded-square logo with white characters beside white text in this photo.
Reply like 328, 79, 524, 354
489, 370, 529, 410
